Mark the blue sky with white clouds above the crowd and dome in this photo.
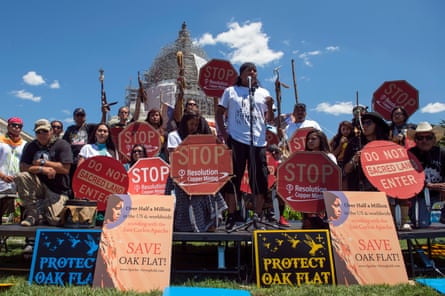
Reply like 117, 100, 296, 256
0, 0, 445, 137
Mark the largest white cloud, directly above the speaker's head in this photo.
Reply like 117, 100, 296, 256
196, 22, 284, 66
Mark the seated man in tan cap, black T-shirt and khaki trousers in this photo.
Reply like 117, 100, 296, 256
14, 119, 73, 226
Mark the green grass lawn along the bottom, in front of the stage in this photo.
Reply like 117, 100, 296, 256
0, 237, 441, 296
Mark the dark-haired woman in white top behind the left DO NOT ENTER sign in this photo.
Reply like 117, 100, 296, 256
78, 123, 117, 166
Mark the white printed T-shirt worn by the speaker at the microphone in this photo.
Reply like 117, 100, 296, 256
219, 85, 270, 147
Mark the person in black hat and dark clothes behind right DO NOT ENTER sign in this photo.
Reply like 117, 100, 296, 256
343, 112, 389, 191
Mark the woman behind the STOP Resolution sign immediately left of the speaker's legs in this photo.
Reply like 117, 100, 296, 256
167, 110, 227, 232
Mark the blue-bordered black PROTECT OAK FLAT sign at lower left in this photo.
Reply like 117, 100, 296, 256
29, 228, 100, 287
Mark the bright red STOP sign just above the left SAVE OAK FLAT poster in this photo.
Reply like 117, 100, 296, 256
128, 157, 170, 195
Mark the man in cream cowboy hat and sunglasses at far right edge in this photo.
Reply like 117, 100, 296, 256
407, 122, 445, 228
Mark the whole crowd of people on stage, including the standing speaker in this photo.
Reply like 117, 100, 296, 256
0, 63, 445, 240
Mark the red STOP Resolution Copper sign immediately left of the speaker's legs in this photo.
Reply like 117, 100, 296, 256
170, 135, 233, 195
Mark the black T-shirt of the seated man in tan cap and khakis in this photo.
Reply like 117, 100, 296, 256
20, 139, 73, 194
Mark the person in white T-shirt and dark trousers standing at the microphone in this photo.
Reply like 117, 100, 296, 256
215, 63, 274, 230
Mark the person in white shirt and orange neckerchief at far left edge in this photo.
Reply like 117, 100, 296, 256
0, 117, 26, 224
